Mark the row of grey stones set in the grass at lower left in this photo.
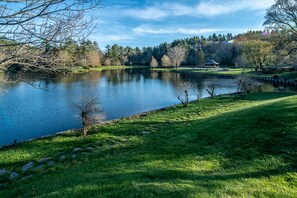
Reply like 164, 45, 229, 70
0, 138, 128, 184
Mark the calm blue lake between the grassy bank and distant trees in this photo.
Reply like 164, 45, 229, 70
0, 69, 289, 146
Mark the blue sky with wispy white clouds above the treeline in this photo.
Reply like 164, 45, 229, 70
90, 0, 274, 49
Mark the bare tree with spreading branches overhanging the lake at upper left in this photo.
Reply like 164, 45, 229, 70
0, 0, 101, 73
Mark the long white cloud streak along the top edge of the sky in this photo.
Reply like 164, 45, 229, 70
123, 0, 275, 20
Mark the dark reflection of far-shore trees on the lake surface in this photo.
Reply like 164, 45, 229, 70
0, 69, 294, 95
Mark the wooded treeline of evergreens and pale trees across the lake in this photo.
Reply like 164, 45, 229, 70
0, 31, 297, 72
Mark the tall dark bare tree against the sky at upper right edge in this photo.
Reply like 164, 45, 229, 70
264, 0, 297, 54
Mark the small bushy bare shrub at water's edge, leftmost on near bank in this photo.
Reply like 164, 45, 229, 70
73, 97, 105, 136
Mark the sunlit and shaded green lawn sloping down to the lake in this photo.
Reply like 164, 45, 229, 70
0, 93, 297, 198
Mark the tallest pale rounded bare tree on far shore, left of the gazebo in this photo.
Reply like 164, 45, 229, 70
168, 46, 187, 69
